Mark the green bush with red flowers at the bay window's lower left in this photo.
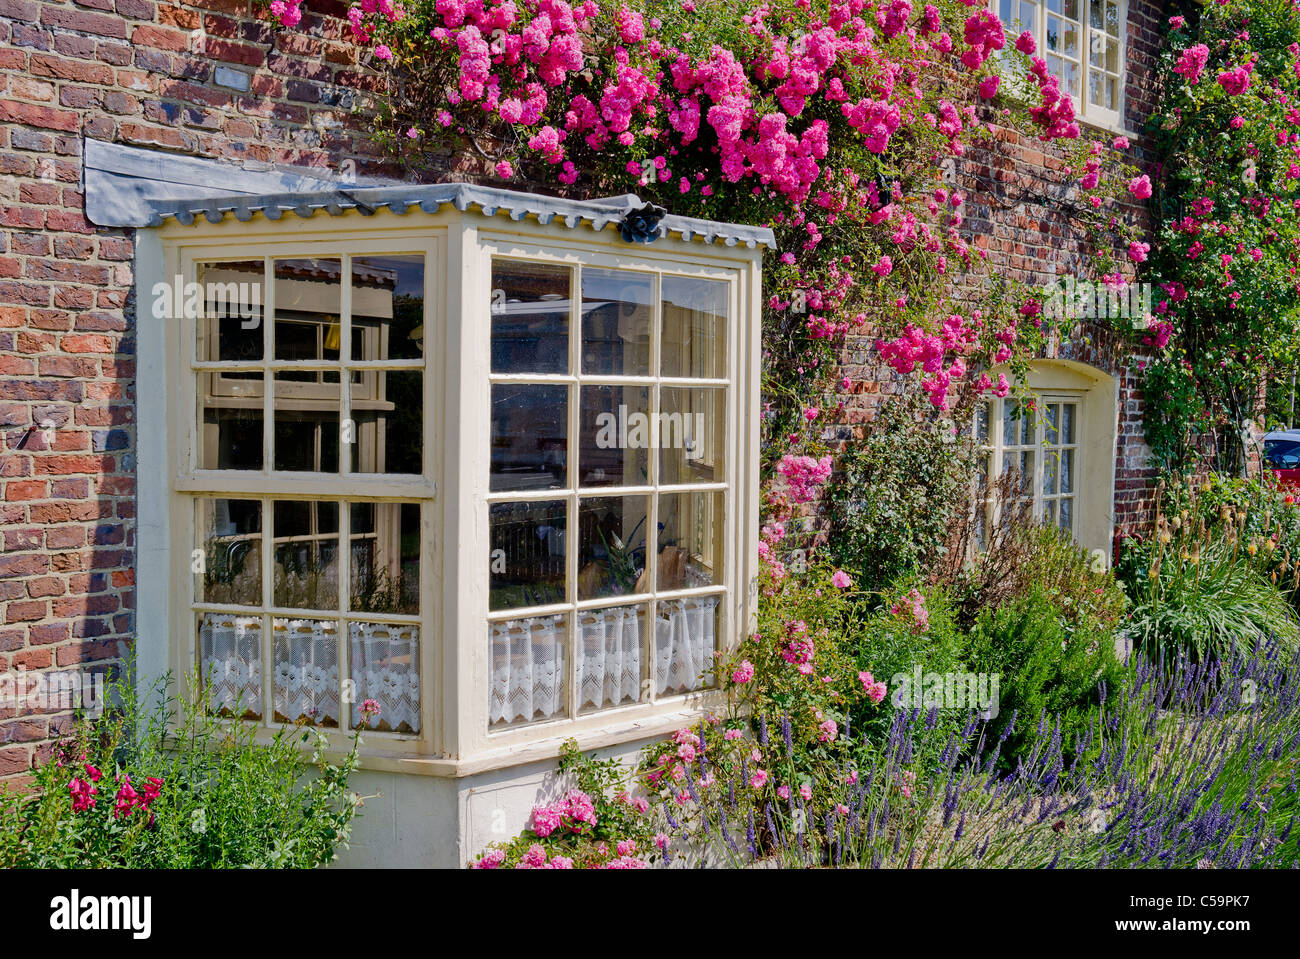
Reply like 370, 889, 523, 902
0, 684, 360, 869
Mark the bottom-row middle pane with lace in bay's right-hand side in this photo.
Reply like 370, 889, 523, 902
577, 606, 647, 712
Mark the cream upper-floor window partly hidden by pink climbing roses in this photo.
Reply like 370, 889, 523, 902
993, 0, 1127, 129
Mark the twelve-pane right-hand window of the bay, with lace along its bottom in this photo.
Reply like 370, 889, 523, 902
489, 257, 735, 729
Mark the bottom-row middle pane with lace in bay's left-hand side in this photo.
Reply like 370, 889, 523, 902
272, 619, 339, 726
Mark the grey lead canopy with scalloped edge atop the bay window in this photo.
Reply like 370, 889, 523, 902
85, 140, 776, 249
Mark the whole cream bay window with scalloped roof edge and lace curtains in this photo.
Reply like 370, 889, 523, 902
138, 185, 771, 774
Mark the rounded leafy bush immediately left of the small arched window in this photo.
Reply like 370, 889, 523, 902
829, 398, 971, 590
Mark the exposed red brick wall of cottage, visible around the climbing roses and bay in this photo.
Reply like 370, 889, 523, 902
0, 0, 1162, 782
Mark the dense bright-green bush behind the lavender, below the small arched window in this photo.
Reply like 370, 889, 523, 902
967, 585, 1126, 761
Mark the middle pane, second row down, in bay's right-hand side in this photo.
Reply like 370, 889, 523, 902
577, 386, 654, 486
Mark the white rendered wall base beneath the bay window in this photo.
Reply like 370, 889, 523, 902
335, 739, 660, 869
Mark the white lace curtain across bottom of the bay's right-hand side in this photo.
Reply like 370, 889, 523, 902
488, 596, 719, 725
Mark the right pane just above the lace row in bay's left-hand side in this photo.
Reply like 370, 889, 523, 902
350, 503, 420, 616
